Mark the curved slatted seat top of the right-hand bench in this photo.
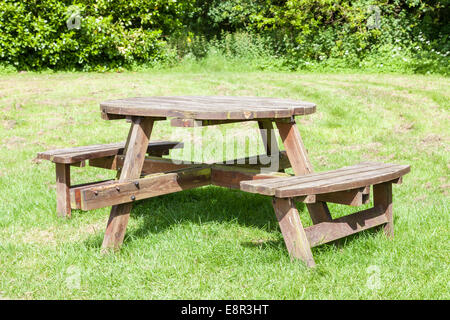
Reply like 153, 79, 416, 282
241, 162, 410, 198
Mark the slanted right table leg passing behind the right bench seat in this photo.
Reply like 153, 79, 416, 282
276, 120, 332, 224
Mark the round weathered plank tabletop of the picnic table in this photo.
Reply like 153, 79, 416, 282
100, 96, 316, 120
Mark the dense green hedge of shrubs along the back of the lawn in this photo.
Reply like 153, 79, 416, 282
0, 0, 450, 74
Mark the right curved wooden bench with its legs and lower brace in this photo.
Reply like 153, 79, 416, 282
240, 162, 410, 266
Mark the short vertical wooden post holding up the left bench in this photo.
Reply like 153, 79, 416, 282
56, 163, 72, 218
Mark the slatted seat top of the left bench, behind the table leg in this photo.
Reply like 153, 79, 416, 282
37, 140, 183, 164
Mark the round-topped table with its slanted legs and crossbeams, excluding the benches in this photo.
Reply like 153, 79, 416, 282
99, 96, 331, 249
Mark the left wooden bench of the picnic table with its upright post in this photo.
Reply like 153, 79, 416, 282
37, 140, 183, 217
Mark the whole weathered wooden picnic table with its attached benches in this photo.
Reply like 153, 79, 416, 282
38, 96, 410, 267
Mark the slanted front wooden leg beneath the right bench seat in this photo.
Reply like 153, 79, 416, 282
273, 198, 315, 267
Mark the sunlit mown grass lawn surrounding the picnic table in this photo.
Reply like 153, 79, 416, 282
0, 70, 450, 299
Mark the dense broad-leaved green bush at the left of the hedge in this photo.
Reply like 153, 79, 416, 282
0, 0, 185, 70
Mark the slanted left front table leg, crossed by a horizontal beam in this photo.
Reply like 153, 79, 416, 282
102, 117, 153, 251
